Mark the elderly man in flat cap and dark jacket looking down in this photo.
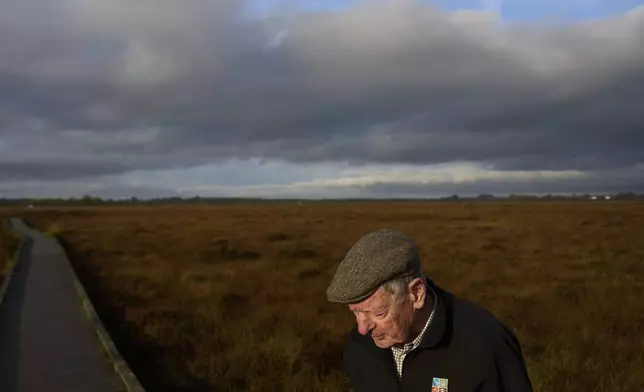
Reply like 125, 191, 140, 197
326, 229, 532, 392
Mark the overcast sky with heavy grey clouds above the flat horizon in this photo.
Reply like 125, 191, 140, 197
0, 0, 644, 198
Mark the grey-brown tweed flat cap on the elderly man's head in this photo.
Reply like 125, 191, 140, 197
326, 229, 420, 304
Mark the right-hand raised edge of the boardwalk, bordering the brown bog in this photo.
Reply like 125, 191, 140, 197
54, 237, 146, 392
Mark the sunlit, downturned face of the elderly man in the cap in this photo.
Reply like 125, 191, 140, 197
349, 287, 414, 348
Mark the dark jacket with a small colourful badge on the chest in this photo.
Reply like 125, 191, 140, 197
343, 279, 532, 392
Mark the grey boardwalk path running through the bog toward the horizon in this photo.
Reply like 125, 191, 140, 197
0, 219, 125, 392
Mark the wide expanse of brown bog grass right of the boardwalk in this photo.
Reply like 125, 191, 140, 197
8, 202, 644, 392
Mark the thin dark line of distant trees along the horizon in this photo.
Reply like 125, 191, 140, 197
0, 192, 644, 207
